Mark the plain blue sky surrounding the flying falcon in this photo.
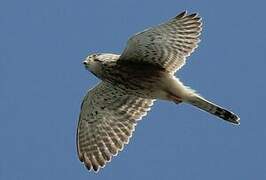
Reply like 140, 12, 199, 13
0, 0, 266, 180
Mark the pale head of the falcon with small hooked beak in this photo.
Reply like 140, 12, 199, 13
83, 54, 102, 75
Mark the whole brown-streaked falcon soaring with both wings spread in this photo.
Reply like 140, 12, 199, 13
77, 11, 240, 172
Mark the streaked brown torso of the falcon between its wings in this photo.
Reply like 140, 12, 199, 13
88, 54, 191, 101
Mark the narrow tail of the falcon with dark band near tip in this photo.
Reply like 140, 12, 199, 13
188, 96, 240, 124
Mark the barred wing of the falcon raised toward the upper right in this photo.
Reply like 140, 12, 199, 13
119, 12, 202, 73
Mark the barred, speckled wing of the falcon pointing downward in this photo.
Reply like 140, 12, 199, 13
77, 82, 154, 171
